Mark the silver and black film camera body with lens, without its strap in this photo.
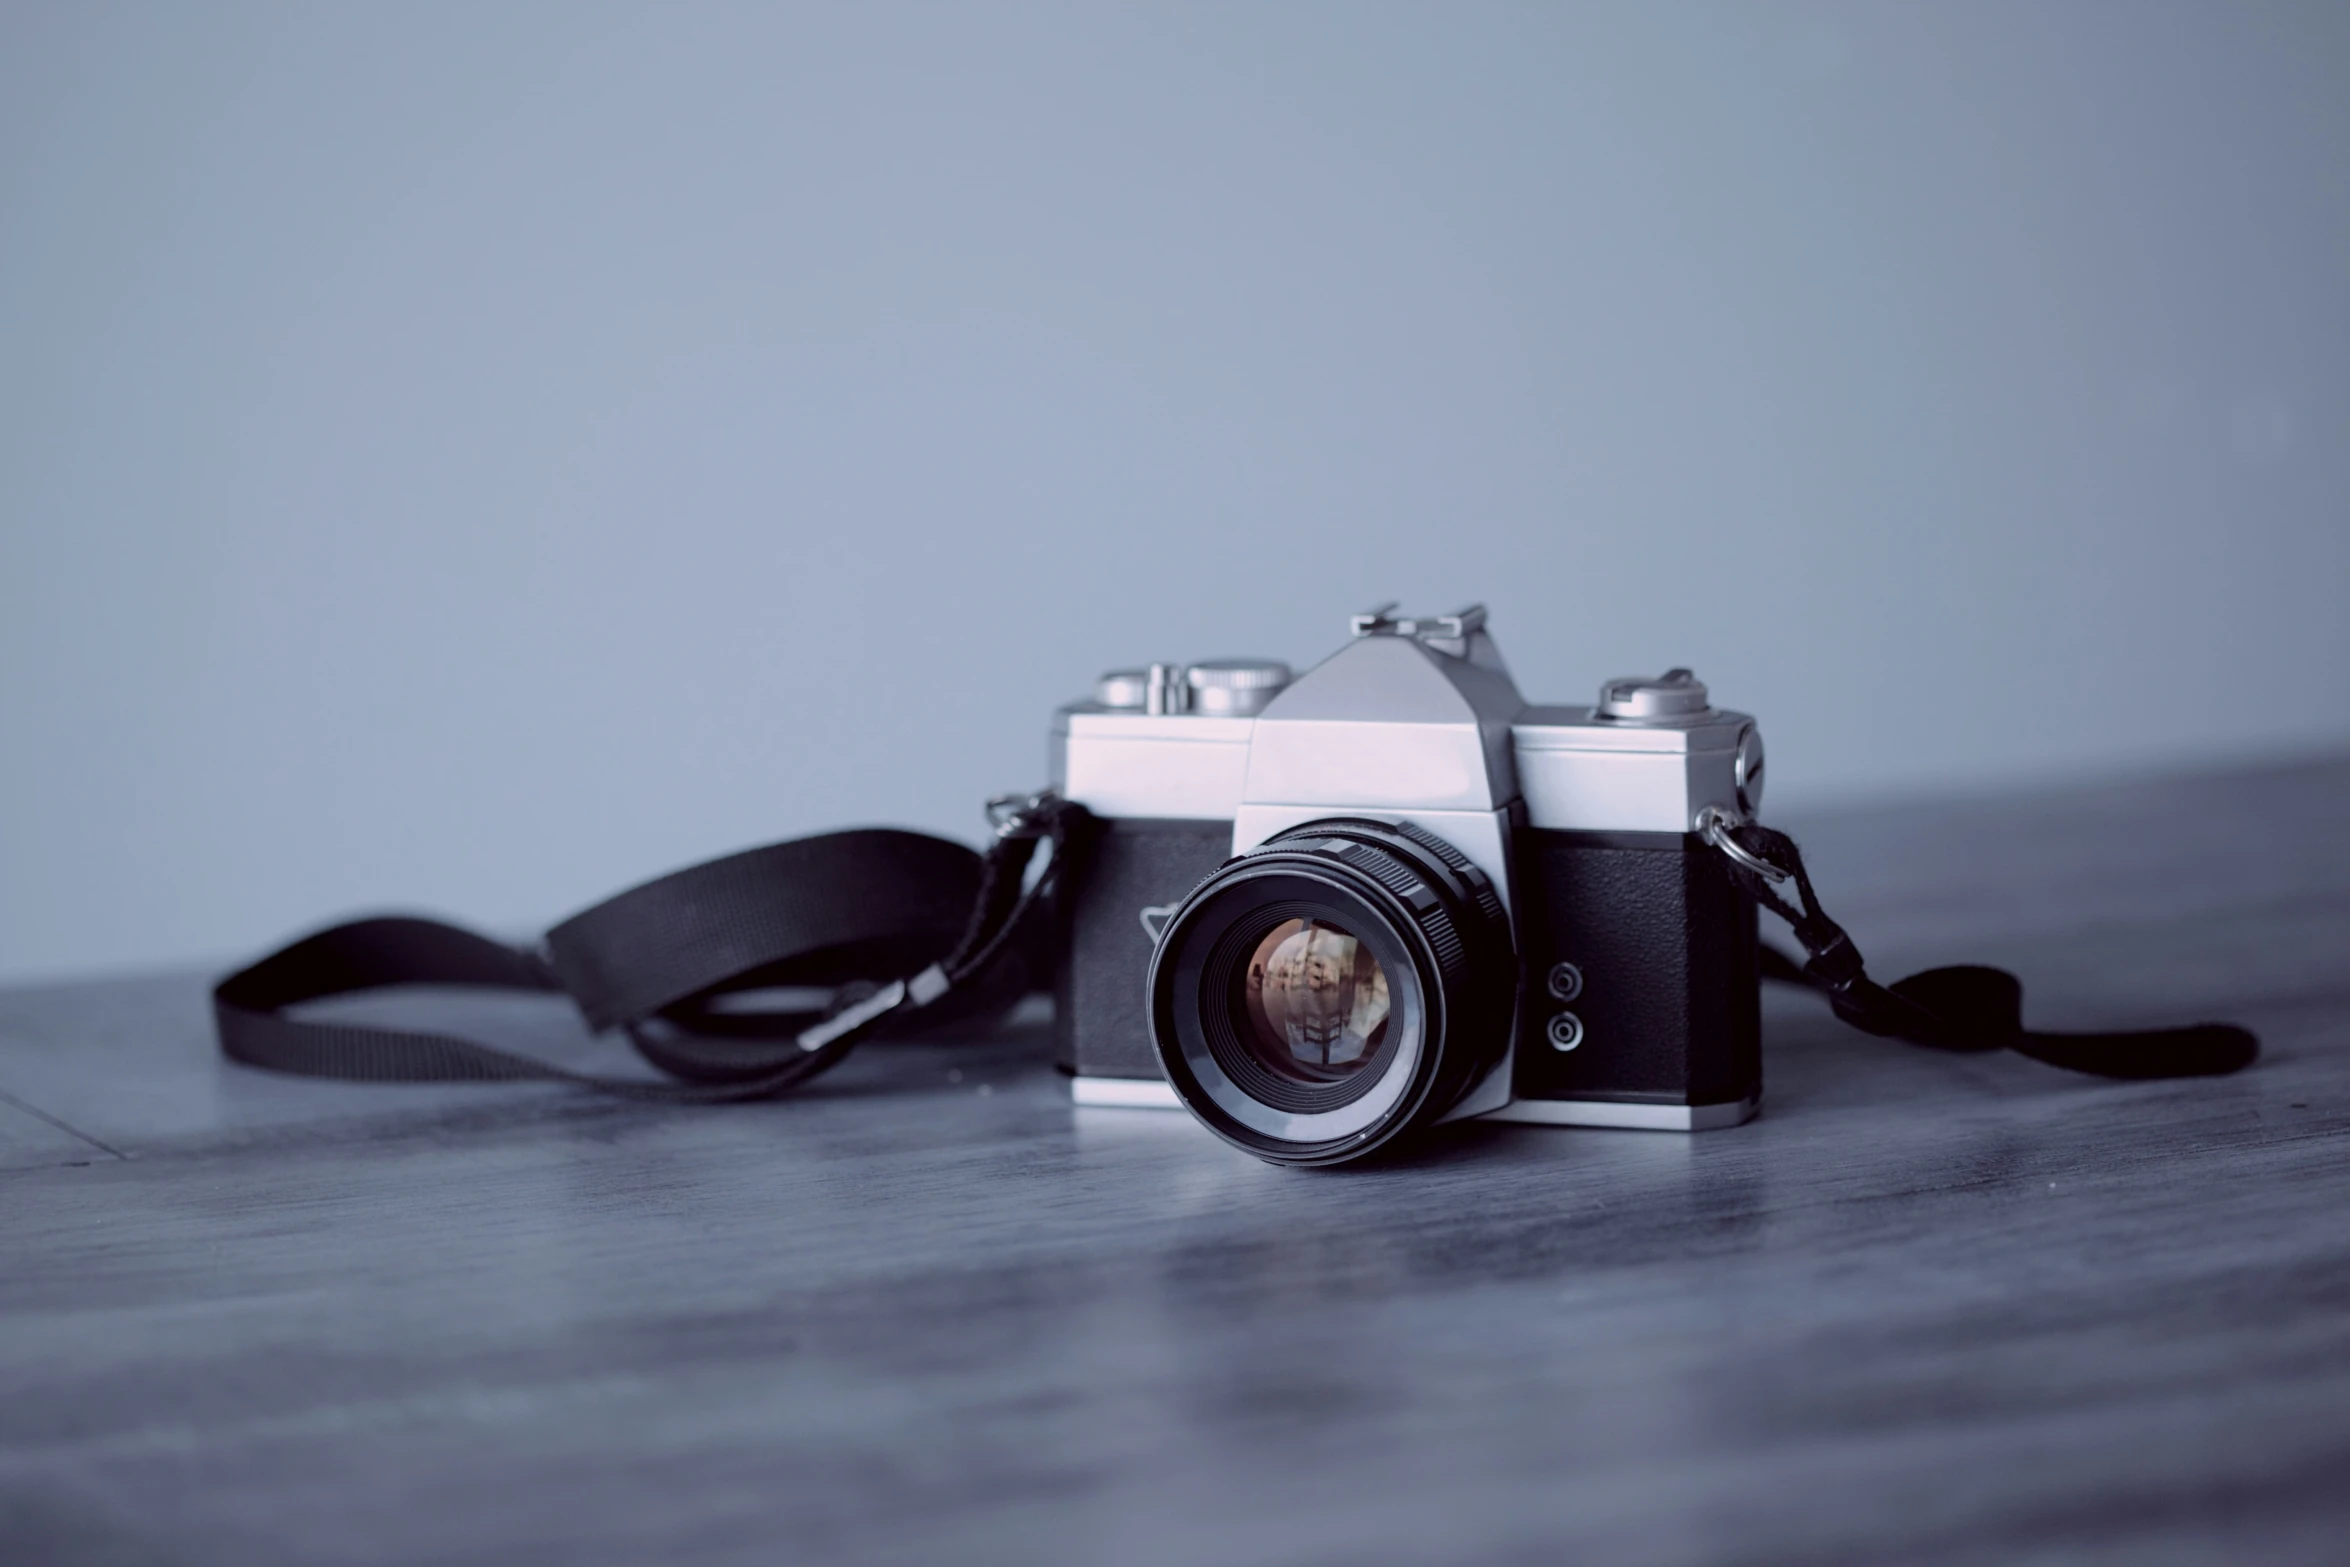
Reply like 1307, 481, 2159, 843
1053, 606, 1763, 1165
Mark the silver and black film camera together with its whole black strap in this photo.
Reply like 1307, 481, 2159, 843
212, 606, 2261, 1141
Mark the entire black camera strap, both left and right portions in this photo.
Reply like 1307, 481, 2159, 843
212, 794, 2261, 1102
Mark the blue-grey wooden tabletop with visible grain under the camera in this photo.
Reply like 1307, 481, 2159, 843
0, 761, 2350, 1567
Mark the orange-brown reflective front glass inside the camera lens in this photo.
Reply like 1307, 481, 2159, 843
1246, 919, 1389, 1081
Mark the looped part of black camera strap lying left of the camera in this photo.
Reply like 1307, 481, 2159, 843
212, 794, 1081, 1102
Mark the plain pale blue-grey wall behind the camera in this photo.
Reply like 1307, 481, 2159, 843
0, 2, 2350, 977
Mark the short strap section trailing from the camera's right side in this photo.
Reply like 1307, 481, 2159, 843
1699, 806, 2261, 1078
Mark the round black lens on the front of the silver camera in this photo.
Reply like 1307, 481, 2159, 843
1149, 818, 1516, 1165
